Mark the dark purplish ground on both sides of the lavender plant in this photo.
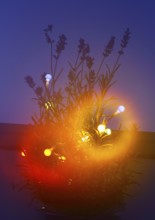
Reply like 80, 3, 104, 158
0, 124, 155, 220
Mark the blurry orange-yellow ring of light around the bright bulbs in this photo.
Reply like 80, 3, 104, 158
64, 95, 137, 162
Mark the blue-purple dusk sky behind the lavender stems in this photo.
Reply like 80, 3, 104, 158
0, 0, 155, 131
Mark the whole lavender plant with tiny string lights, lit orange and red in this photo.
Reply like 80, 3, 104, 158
18, 25, 137, 215
